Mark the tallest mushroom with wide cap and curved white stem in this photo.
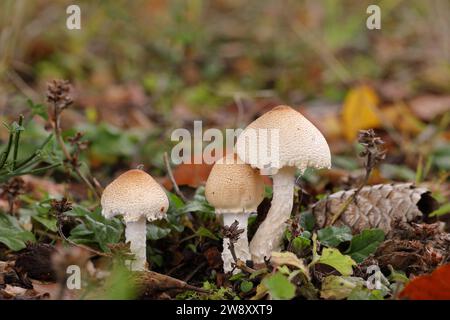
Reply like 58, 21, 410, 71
236, 106, 331, 263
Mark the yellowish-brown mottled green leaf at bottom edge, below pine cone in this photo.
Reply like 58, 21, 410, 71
320, 276, 364, 300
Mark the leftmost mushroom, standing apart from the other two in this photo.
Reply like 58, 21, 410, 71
101, 169, 169, 271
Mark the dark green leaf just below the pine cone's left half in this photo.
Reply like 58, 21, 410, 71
346, 229, 384, 263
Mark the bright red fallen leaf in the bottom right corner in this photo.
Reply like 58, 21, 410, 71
399, 264, 450, 300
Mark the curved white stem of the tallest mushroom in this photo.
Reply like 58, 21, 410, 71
250, 167, 296, 263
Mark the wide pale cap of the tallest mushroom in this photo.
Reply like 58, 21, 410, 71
236, 106, 331, 173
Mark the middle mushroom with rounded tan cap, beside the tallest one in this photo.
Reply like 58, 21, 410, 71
205, 154, 264, 272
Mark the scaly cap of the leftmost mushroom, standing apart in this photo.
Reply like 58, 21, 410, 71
101, 169, 169, 222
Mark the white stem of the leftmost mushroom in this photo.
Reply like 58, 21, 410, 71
125, 216, 147, 271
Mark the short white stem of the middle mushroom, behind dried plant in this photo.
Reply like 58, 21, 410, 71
222, 212, 251, 273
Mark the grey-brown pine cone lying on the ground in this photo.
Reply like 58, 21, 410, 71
312, 183, 436, 234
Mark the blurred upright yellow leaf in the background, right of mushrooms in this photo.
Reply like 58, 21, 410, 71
342, 85, 381, 141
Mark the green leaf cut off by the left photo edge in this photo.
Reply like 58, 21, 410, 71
0, 213, 36, 251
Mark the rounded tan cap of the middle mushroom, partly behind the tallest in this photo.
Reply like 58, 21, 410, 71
205, 153, 264, 213
